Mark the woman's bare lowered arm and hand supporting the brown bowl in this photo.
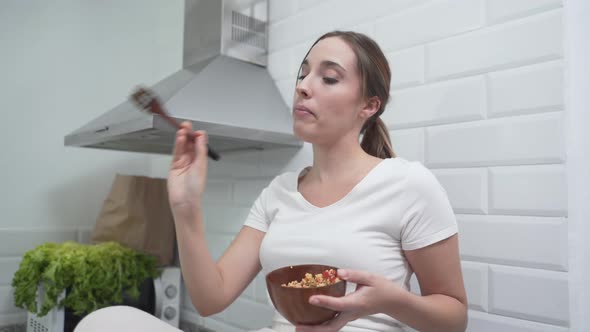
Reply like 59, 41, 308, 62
297, 235, 467, 332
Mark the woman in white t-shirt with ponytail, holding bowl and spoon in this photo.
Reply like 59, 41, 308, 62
76, 31, 467, 332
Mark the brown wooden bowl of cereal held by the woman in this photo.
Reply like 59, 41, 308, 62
266, 264, 346, 325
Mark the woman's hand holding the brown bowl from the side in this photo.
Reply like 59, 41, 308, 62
295, 269, 407, 332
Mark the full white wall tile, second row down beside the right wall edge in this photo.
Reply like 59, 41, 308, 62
426, 10, 563, 80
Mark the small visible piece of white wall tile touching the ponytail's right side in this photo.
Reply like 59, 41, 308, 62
389, 128, 425, 163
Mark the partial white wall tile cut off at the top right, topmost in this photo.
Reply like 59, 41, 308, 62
487, 0, 562, 23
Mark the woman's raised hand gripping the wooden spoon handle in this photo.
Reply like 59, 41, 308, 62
168, 121, 208, 212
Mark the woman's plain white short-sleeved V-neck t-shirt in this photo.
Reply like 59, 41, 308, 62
245, 157, 457, 331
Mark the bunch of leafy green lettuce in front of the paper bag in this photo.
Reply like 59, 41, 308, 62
12, 241, 161, 317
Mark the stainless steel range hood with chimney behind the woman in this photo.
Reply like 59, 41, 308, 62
64, 0, 302, 154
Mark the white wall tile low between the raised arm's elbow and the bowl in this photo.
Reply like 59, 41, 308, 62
226, 298, 274, 330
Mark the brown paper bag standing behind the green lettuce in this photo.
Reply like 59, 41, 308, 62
91, 174, 175, 266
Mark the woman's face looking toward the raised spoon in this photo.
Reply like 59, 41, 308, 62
293, 37, 370, 144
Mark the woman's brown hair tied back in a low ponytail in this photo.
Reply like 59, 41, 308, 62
304, 31, 395, 158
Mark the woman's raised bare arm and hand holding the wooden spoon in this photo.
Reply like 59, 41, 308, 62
168, 122, 264, 316
